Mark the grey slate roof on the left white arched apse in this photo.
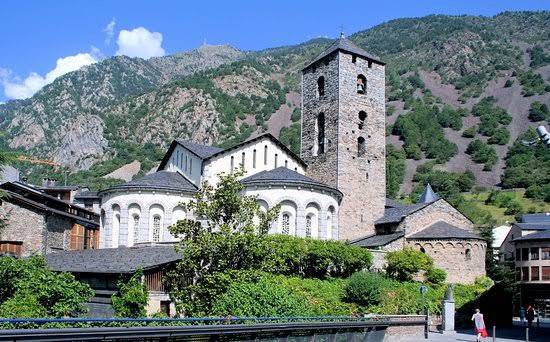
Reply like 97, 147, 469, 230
103, 171, 197, 192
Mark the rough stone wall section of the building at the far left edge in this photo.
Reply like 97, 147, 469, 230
0, 201, 44, 256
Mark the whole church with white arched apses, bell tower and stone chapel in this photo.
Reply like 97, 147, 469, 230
95, 36, 487, 283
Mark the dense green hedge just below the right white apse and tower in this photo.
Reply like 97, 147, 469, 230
267, 235, 372, 278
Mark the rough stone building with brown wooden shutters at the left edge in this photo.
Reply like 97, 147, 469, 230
0, 182, 100, 256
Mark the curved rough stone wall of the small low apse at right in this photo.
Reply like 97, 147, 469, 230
407, 239, 487, 284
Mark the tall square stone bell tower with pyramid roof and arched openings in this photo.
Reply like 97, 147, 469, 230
301, 35, 386, 240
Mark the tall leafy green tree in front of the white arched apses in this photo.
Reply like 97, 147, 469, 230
168, 169, 279, 315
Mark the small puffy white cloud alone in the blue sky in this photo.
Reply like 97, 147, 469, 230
116, 27, 165, 59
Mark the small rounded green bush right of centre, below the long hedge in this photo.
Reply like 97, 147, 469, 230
344, 272, 392, 306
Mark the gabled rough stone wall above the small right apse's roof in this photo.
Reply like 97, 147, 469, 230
398, 199, 474, 237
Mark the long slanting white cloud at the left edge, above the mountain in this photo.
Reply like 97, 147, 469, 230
0, 53, 97, 99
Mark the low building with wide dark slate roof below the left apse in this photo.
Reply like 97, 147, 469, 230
46, 246, 181, 317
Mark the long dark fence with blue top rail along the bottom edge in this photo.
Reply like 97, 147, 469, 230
0, 316, 427, 342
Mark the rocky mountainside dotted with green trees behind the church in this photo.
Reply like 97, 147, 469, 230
0, 12, 550, 200
